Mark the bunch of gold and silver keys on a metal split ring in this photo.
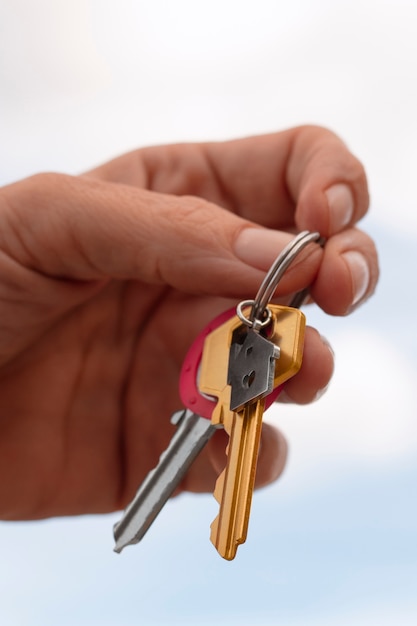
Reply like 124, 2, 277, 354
114, 231, 321, 560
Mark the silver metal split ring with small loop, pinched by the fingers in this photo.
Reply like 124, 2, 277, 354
236, 230, 323, 332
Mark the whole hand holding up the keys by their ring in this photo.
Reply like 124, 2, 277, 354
0, 127, 378, 519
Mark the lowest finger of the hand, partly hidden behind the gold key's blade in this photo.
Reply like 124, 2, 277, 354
181, 423, 288, 492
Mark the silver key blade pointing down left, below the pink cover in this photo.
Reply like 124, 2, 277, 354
113, 409, 218, 552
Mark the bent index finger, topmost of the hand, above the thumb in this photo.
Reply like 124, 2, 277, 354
89, 126, 369, 237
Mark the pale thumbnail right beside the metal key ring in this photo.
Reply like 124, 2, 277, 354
234, 228, 292, 271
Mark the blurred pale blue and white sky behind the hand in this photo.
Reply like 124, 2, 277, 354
0, 0, 417, 626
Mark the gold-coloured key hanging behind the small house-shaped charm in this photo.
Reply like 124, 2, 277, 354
199, 305, 305, 560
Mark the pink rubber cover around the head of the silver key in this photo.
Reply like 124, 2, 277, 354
179, 308, 282, 419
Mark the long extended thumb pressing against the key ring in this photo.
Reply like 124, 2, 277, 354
0, 174, 321, 297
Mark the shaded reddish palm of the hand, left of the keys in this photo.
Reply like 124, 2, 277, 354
0, 272, 231, 518
